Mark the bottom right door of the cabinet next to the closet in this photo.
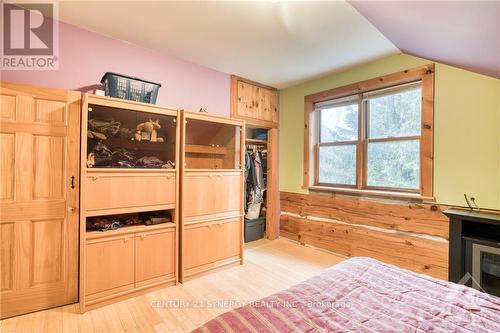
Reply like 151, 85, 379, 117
211, 219, 242, 260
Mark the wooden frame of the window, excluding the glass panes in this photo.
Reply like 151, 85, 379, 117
303, 64, 434, 199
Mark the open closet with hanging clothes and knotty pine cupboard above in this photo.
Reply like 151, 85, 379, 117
231, 75, 280, 241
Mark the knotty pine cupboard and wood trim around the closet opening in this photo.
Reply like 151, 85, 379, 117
231, 75, 280, 239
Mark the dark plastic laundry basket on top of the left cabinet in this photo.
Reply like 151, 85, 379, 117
101, 72, 161, 104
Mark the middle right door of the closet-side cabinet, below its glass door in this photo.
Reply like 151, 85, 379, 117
213, 172, 243, 213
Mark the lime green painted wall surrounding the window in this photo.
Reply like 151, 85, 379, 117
280, 54, 500, 209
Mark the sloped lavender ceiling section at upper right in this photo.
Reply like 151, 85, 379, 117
350, 1, 500, 78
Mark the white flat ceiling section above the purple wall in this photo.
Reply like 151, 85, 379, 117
59, 1, 399, 88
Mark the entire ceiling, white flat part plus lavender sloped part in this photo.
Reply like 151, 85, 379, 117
59, 1, 500, 88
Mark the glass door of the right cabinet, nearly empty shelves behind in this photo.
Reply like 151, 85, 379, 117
185, 119, 241, 169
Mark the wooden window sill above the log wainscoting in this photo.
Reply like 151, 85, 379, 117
308, 186, 436, 202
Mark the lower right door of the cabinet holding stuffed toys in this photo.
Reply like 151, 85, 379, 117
135, 229, 175, 283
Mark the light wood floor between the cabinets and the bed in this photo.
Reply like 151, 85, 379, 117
0, 238, 344, 333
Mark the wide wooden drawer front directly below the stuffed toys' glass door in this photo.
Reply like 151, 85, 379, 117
85, 172, 175, 211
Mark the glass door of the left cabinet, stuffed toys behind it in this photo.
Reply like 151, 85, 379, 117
87, 104, 176, 169
